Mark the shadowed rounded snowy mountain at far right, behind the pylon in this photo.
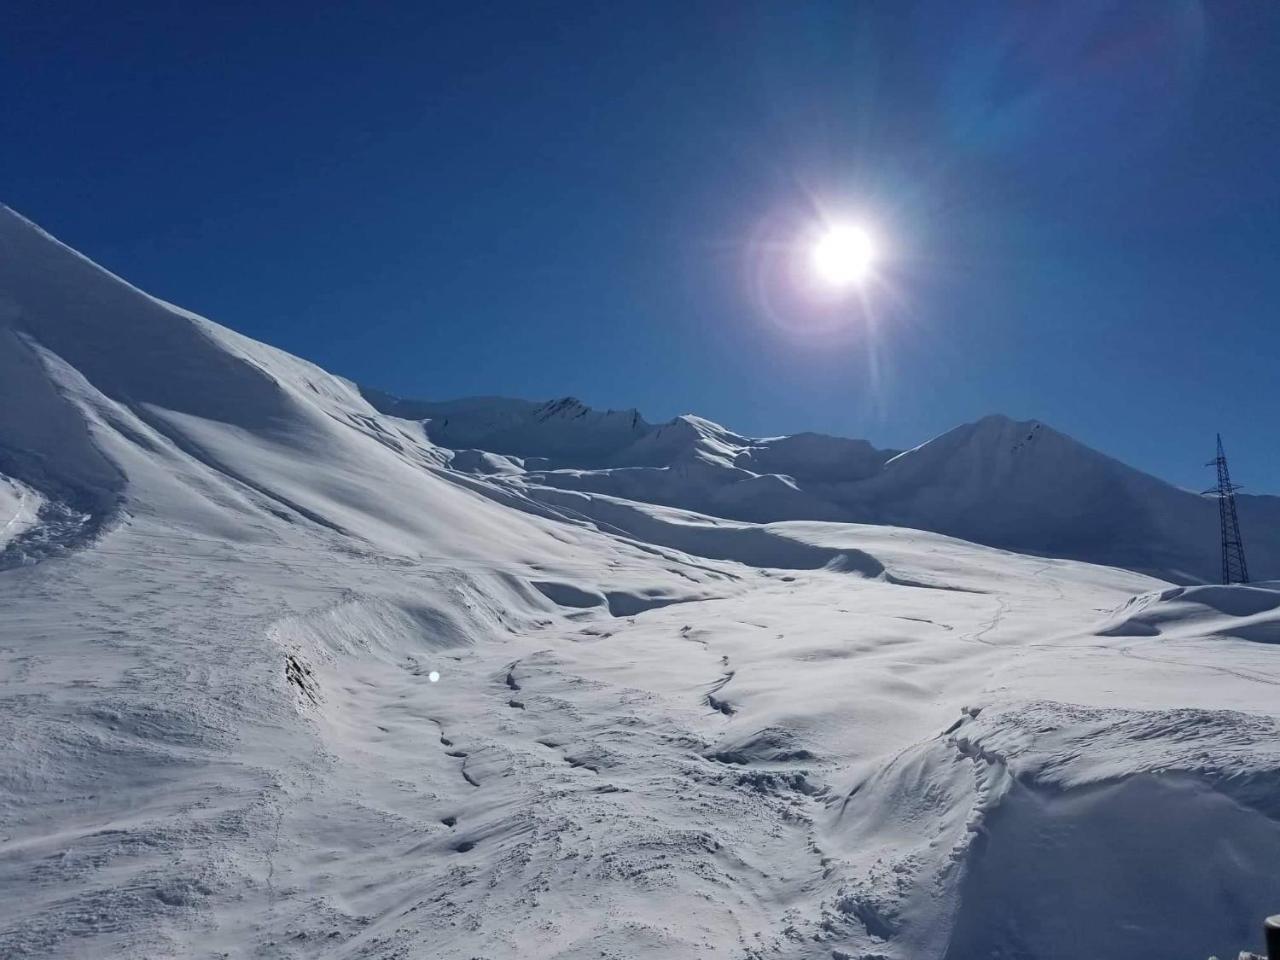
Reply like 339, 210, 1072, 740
844, 417, 1280, 581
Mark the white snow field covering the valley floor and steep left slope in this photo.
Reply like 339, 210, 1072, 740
0, 199, 1280, 960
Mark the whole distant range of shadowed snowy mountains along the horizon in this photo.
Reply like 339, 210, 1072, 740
366, 390, 1280, 582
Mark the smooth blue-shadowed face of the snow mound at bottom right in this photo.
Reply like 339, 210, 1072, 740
946, 774, 1280, 960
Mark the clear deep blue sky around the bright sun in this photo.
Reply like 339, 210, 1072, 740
0, 0, 1280, 493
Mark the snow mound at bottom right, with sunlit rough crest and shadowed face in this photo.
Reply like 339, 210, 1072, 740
946, 703, 1280, 960
